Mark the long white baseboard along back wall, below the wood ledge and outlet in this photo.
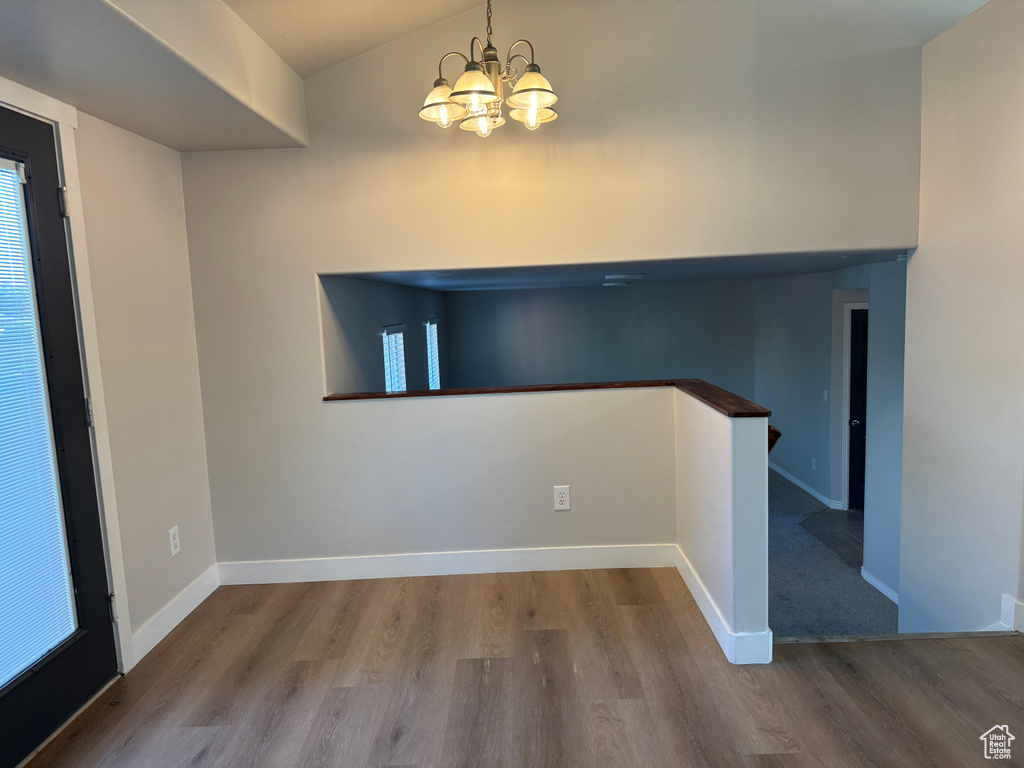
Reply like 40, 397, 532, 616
220, 544, 676, 585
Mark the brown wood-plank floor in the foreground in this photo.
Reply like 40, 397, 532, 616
22, 568, 1024, 768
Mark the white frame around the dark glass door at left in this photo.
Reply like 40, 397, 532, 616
0, 77, 136, 673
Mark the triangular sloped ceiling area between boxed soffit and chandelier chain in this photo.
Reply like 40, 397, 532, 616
224, 0, 483, 77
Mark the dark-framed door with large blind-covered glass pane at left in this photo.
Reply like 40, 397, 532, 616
0, 109, 117, 768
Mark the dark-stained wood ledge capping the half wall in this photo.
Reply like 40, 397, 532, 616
324, 379, 771, 419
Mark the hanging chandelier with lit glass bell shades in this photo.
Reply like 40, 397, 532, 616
420, 0, 558, 136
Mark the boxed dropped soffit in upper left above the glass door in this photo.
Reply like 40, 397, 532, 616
0, 0, 306, 151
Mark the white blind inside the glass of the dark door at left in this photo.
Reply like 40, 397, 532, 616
0, 161, 76, 687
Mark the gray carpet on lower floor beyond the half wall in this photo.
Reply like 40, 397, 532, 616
768, 471, 897, 638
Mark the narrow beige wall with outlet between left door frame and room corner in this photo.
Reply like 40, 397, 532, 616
76, 114, 215, 630
